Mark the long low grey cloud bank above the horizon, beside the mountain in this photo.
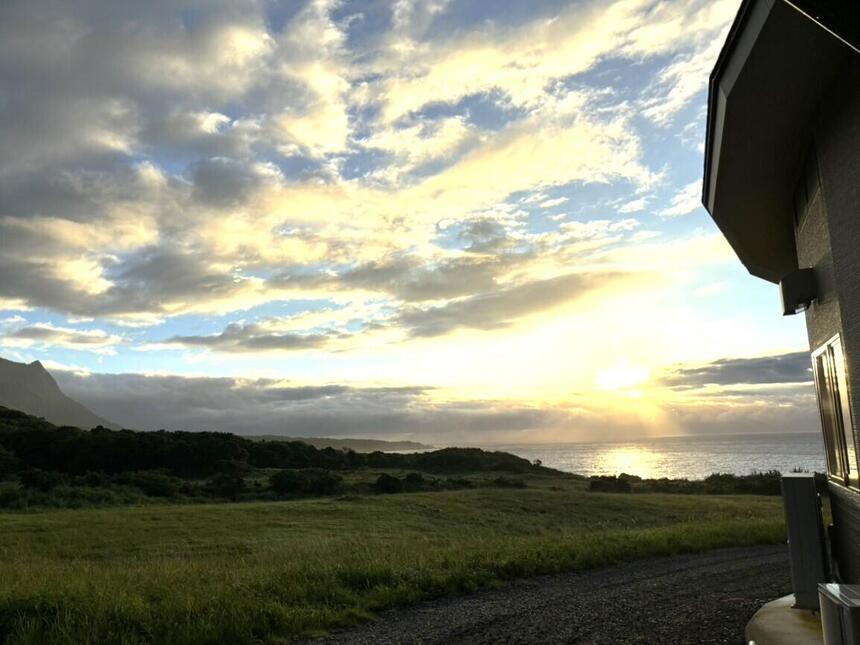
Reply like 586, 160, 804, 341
54, 371, 560, 444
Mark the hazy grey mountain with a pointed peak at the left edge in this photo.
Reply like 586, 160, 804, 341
0, 358, 118, 429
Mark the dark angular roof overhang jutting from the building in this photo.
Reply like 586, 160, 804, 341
702, 0, 853, 282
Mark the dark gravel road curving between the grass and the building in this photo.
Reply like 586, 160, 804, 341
310, 545, 791, 645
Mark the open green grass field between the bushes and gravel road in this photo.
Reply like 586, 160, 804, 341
0, 477, 784, 643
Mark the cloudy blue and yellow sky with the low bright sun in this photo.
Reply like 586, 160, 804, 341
0, 0, 817, 444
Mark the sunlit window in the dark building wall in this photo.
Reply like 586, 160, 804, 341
812, 335, 858, 486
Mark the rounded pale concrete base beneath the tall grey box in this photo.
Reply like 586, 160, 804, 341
745, 595, 824, 645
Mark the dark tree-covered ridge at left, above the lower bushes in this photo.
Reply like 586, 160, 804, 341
0, 407, 540, 478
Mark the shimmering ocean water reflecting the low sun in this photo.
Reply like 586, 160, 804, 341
492, 432, 825, 479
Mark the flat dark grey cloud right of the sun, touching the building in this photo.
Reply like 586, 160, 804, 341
664, 352, 813, 389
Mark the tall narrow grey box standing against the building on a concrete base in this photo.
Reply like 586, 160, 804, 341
782, 473, 829, 610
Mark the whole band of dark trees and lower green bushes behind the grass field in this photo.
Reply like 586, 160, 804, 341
0, 407, 556, 510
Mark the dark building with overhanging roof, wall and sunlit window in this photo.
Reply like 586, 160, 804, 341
702, 0, 860, 640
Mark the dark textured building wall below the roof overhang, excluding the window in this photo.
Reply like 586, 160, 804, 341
808, 60, 860, 582
